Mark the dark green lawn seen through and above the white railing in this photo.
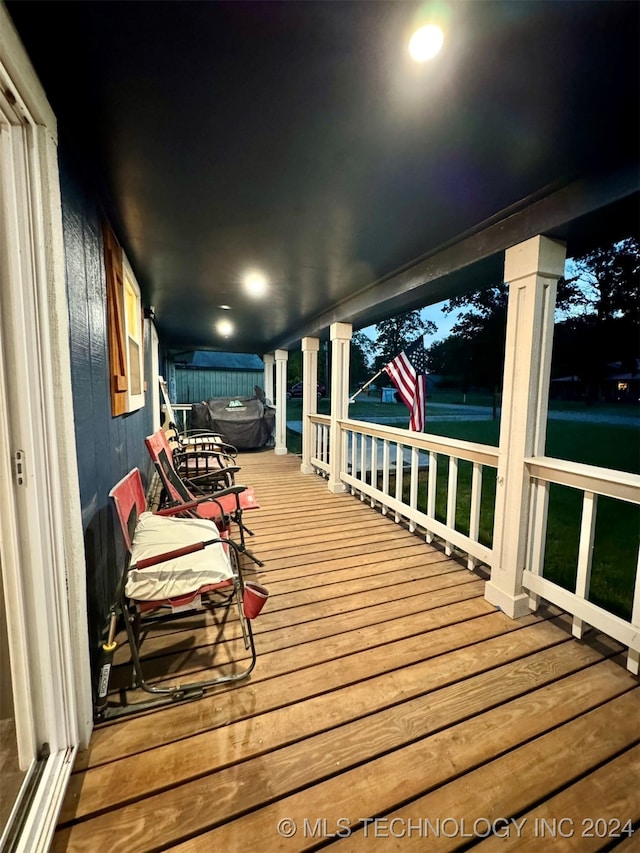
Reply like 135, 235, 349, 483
287, 398, 640, 619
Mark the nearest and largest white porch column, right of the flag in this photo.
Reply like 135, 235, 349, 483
485, 236, 566, 619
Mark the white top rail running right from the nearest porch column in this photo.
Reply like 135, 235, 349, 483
525, 456, 640, 503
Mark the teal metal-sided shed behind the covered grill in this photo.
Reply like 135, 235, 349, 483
174, 351, 264, 403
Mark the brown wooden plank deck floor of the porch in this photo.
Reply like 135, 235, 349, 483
53, 451, 640, 853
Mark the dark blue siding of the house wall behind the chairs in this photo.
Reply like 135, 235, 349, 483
60, 157, 153, 684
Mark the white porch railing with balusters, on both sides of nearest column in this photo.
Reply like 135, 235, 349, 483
310, 415, 640, 674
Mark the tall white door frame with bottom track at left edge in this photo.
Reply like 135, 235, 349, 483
0, 3, 93, 851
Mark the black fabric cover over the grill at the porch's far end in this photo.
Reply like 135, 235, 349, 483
191, 397, 276, 450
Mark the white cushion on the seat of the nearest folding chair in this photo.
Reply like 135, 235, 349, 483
125, 512, 233, 601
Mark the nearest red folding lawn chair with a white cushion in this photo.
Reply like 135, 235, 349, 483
96, 468, 266, 719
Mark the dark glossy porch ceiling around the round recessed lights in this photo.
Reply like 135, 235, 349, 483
7, 0, 640, 352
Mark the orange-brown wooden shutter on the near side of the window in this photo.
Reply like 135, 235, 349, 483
102, 222, 128, 417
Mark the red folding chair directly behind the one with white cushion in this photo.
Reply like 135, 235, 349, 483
144, 429, 263, 566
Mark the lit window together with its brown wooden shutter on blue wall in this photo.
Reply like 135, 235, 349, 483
104, 225, 144, 417
